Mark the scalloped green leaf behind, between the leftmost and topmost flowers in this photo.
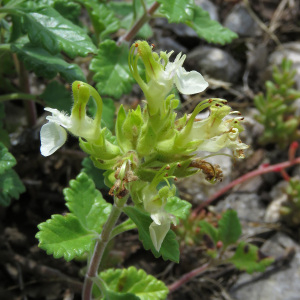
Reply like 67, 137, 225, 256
90, 40, 135, 98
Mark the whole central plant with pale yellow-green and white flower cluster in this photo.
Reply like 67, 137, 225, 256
37, 41, 248, 299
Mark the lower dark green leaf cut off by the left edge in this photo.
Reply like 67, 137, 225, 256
0, 169, 25, 206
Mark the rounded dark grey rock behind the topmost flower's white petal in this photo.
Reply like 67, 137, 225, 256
186, 46, 241, 82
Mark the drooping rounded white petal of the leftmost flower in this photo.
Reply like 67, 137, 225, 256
40, 122, 67, 156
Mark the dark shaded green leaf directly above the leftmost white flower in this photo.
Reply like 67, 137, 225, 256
40, 81, 73, 114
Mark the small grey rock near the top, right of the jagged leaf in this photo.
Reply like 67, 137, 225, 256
224, 4, 261, 37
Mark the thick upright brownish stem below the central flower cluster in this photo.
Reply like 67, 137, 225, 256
82, 196, 128, 300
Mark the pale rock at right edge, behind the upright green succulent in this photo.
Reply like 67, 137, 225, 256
269, 42, 300, 89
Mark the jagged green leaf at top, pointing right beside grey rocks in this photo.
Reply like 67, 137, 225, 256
185, 6, 238, 45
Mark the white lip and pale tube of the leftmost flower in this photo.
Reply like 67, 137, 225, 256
40, 107, 100, 156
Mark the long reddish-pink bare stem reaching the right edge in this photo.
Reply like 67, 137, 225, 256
193, 157, 300, 214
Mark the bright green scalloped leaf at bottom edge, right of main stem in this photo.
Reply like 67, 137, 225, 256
99, 267, 169, 300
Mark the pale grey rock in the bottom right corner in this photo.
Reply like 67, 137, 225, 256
230, 233, 300, 300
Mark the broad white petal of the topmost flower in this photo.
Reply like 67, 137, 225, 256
174, 67, 208, 95
